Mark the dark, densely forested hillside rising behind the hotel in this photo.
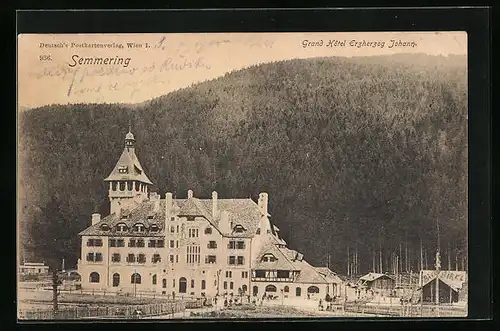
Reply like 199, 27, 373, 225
19, 55, 467, 272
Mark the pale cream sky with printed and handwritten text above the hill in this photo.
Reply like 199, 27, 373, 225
17, 32, 467, 111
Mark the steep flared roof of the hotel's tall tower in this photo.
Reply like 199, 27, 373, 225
104, 147, 153, 185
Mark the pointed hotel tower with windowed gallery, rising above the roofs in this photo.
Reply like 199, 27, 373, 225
104, 127, 153, 214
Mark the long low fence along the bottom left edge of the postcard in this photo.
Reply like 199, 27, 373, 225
19, 301, 185, 320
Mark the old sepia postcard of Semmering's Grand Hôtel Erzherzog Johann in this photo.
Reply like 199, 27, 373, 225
17, 31, 468, 321
